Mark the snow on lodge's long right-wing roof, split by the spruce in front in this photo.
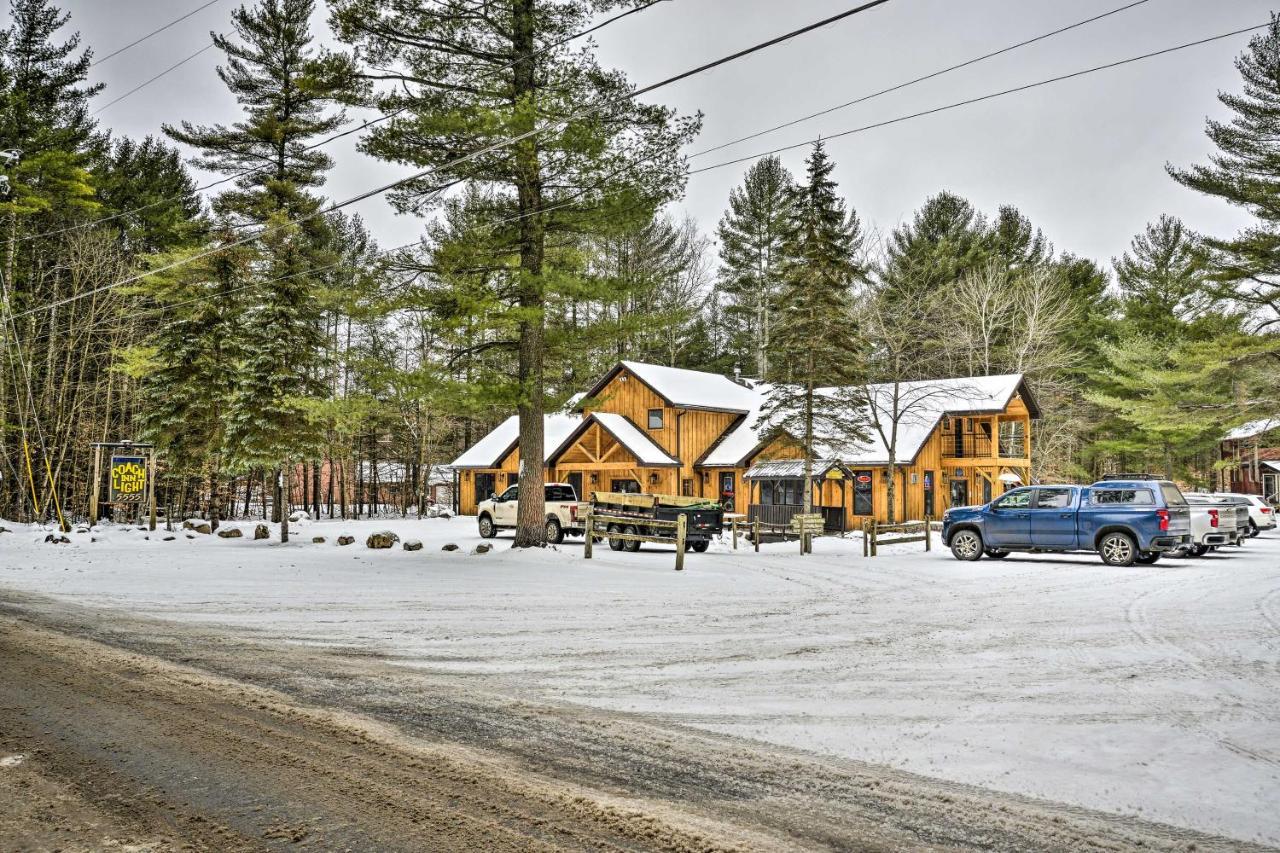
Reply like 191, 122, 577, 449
701, 374, 1023, 466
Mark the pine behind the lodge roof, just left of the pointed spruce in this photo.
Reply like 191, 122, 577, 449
717, 156, 795, 378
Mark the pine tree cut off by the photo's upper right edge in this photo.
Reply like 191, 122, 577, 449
1169, 14, 1280, 328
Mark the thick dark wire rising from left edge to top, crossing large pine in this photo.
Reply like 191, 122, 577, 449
15, 0, 891, 319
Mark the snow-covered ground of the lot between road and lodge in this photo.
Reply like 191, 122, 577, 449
0, 519, 1280, 844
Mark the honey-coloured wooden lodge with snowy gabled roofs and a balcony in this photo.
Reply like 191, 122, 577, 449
453, 361, 1039, 530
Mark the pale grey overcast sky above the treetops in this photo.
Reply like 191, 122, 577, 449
30, 0, 1270, 263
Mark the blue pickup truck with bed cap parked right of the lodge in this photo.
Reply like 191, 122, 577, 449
942, 479, 1192, 566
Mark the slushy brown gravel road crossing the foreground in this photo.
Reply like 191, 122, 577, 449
0, 593, 1261, 850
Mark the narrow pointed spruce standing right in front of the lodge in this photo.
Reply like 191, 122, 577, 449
762, 142, 867, 545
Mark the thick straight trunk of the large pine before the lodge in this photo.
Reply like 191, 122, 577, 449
512, 0, 547, 548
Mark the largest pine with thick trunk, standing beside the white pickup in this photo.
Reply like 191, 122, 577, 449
332, 0, 698, 547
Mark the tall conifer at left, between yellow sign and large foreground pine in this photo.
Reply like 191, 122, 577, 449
164, 0, 344, 539
